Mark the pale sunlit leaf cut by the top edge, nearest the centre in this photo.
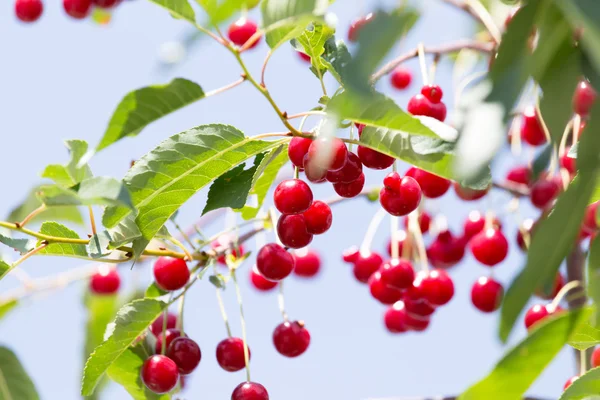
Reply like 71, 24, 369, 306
261, 0, 329, 49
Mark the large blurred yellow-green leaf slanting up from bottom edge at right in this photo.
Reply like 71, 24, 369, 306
458, 308, 591, 400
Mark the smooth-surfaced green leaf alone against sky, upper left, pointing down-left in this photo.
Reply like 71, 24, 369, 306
96, 78, 204, 151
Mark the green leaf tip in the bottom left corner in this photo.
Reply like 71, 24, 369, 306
0, 347, 40, 400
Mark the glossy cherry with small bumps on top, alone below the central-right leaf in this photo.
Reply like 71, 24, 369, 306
379, 172, 421, 217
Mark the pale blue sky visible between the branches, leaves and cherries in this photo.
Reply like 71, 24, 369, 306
0, 0, 575, 400
